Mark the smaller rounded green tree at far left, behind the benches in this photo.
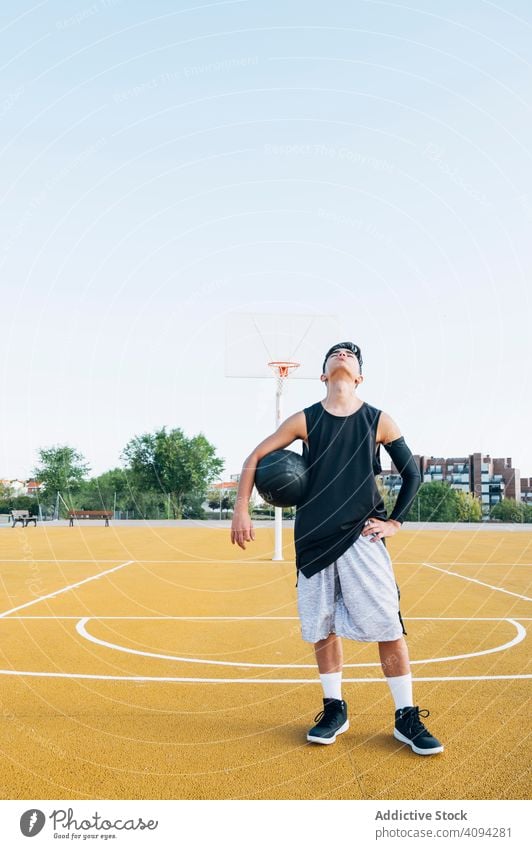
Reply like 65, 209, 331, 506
31, 445, 89, 506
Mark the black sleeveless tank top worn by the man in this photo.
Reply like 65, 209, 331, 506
294, 402, 386, 578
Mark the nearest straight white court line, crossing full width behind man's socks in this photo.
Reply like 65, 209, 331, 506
0, 669, 532, 686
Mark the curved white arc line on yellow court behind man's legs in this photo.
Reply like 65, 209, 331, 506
76, 616, 526, 669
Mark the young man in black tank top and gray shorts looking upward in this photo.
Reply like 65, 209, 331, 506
231, 342, 443, 755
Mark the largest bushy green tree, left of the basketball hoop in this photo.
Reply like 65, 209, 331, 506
122, 427, 224, 519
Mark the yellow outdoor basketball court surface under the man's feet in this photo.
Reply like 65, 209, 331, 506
0, 525, 532, 799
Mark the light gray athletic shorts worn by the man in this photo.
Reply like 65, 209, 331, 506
297, 536, 405, 643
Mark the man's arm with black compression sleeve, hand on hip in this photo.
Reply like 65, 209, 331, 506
362, 413, 421, 542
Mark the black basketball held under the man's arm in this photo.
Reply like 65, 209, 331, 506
255, 449, 308, 507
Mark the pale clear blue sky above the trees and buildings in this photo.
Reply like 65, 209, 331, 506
0, 0, 532, 477
